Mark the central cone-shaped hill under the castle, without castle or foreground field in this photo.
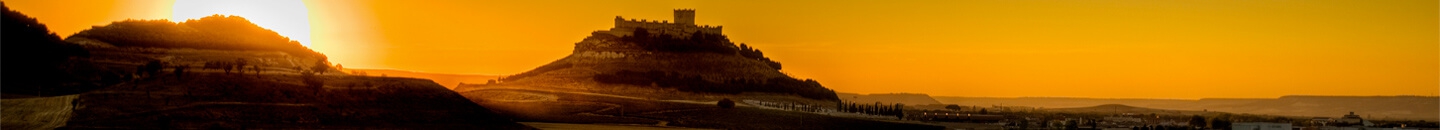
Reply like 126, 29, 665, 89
456, 29, 838, 101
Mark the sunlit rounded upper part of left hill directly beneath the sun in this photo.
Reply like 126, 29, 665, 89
65, 14, 324, 58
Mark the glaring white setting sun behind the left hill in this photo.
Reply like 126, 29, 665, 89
170, 0, 310, 48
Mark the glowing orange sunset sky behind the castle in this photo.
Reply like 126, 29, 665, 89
6, 0, 1440, 98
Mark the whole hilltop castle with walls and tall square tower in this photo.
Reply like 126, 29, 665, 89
609, 9, 721, 36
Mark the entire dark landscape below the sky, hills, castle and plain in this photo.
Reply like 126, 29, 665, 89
0, 3, 1440, 130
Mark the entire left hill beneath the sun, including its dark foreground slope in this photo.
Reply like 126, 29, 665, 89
0, 7, 531, 130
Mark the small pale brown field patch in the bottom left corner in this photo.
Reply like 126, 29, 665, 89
0, 95, 79, 130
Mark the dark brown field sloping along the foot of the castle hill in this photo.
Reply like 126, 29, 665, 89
461, 90, 945, 130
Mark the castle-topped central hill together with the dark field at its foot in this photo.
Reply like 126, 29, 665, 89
455, 10, 945, 130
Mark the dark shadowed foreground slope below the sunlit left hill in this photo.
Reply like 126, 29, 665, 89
59, 72, 530, 129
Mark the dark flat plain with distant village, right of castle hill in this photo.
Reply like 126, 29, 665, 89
744, 96, 1440, 130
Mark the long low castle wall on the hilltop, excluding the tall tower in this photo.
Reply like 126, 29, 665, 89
611, 16, 723, 36
